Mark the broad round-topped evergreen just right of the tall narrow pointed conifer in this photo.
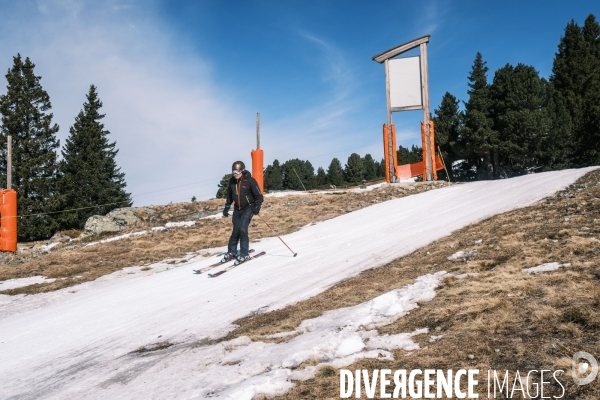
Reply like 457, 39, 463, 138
490, 64, 550, 177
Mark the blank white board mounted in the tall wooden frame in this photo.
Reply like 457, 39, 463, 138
388, 56, 423, 108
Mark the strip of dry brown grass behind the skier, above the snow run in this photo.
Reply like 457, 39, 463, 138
0, 182, 447, 295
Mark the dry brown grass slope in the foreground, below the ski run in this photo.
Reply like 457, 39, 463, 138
218, 171, 600, 399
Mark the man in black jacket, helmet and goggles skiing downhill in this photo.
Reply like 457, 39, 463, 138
221, 161, 263, 263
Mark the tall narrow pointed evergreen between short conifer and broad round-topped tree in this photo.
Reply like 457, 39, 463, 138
461, 53, 499, 179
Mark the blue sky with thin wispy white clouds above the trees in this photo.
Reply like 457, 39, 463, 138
0, 0, 600, 206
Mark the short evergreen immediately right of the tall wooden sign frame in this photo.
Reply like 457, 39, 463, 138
432, 92, 464, 179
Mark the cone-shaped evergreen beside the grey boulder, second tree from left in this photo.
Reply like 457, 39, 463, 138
59, 85, 132, 229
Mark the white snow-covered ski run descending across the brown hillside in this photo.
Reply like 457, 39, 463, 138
0, 168, 594, 399
